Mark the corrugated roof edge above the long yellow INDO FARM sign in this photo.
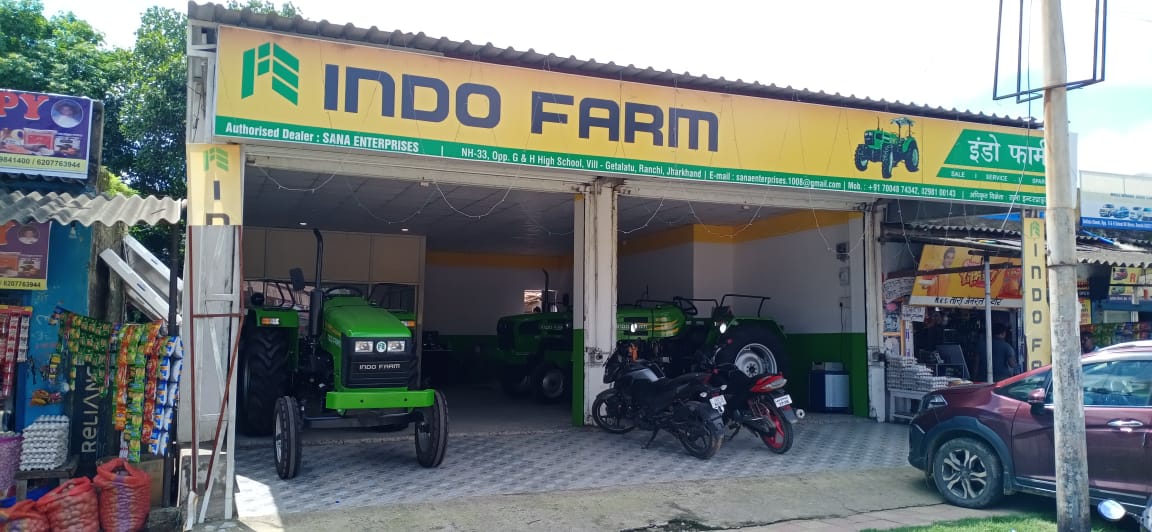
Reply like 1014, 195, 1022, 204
188, 1, 1041, 128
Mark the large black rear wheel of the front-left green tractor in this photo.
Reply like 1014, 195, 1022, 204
236, 326, 289, 436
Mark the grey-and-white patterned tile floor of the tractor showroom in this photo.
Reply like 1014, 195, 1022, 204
236, 415, 908, 517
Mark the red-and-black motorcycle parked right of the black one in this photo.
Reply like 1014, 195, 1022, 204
705, 364, 804, 455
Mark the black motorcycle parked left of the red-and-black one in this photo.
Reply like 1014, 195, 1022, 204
592, 343, 727, 459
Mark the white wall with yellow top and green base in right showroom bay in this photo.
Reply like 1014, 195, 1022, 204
619, 211, 869, 416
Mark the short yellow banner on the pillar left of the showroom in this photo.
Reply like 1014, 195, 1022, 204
188, 144, 244, 226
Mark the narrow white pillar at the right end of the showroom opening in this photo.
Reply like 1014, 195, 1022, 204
863, 205, 888, 421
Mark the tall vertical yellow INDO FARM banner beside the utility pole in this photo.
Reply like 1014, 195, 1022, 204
1021, 218, 1052, 368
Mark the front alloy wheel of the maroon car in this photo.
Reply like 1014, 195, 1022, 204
932, 438, 1003, 508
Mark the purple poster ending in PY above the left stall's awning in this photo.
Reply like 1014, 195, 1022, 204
0, 89, 92, 180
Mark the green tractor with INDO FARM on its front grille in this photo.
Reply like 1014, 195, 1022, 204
237, 230, 448, 479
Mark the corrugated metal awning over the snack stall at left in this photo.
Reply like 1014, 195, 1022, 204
0, 189, 183, 226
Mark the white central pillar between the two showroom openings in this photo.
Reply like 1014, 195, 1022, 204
574, 180, 616, 424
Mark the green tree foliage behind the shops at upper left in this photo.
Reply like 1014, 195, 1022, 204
0, 0, 300, 259
